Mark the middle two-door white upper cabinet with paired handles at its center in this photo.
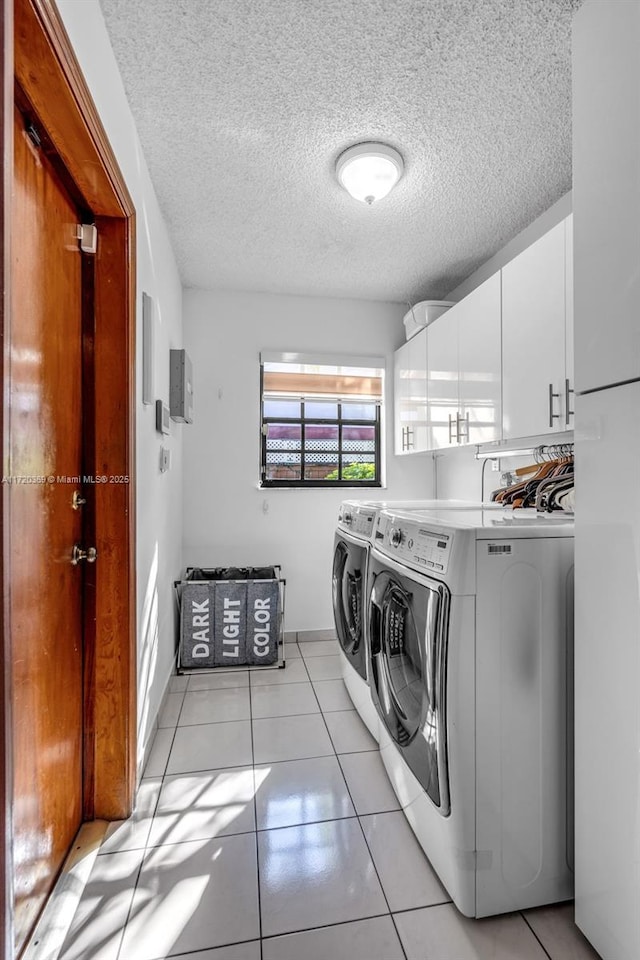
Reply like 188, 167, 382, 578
427, 273, 501, 449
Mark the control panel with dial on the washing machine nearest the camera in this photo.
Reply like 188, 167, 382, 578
373, 513, 453, 576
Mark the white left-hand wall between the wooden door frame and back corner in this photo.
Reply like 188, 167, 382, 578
58, 0, 182, 776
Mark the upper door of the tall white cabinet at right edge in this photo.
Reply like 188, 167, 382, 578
572, 2, 640, 392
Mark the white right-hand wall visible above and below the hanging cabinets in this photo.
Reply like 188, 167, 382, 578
435, 192, 572, 500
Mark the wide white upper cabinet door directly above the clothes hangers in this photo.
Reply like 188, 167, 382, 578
502, 222, 565, 439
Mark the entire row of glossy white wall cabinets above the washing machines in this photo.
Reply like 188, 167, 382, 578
395, 216, 574, 453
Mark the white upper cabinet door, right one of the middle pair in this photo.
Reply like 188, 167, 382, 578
452, 273, 502, 443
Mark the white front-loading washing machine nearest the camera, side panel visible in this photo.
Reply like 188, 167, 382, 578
368, 509, 573, 917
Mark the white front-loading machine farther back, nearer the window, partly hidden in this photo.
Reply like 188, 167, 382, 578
332, 500, 502, 740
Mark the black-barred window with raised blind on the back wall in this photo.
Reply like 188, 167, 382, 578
260, 354, 384, 487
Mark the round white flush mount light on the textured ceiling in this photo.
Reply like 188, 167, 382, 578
336, 143, 404, 204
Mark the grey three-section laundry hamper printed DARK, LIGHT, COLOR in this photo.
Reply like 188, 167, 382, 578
175, 566, 285, 672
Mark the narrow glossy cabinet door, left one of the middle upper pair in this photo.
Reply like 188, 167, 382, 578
427, 316, 460, 450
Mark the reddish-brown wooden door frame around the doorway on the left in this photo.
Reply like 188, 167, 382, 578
0, 0, 137, 957
